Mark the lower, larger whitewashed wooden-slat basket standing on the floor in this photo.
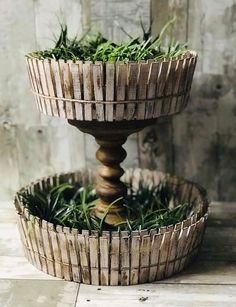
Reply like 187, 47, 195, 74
15, 169, 208, 285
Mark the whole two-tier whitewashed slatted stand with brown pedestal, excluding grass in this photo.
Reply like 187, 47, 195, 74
16, 52, 207, 285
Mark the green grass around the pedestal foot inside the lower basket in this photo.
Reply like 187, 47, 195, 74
20, 183, 193, 233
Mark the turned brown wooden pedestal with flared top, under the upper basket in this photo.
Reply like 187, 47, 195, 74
68, 120, 156, 225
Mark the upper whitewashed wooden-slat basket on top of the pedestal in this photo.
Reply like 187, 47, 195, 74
26, 51, 197, 122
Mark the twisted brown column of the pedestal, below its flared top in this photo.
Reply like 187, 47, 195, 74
95, 134, 127, 224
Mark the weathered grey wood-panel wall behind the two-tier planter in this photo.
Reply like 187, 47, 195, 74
0, 0, 236, 200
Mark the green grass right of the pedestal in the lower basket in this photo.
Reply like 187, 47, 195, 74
117, 183, 192, 230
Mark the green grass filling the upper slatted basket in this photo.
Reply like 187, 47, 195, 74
31, 17, 189, 62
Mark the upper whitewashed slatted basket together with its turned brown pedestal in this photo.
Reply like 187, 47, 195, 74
26, 52, 197, 224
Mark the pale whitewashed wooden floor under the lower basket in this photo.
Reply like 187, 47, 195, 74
0, 203, 236, 307
